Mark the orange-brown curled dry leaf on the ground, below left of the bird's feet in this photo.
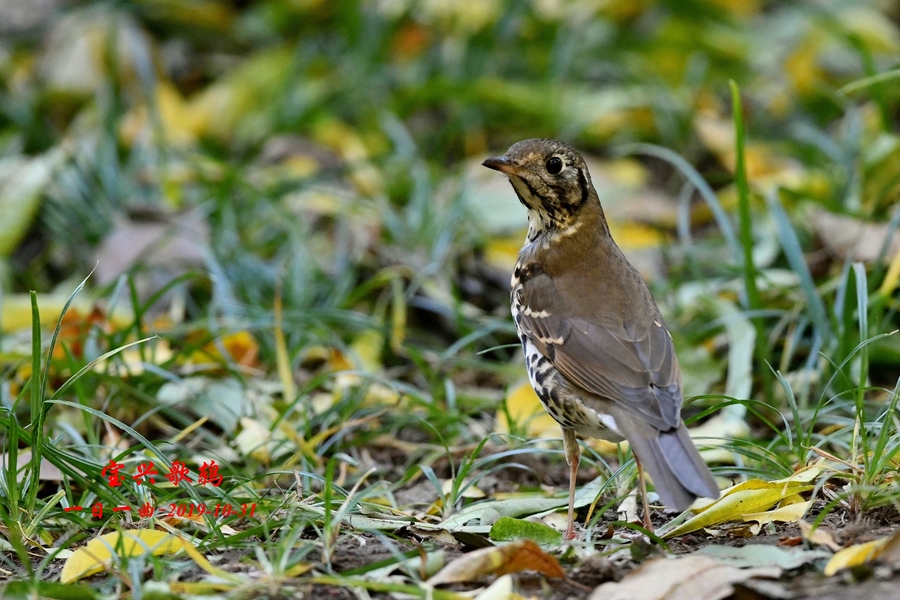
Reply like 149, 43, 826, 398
428, 540, 566, 585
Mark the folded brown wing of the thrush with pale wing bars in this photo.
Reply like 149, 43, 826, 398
516, 275, 682, 431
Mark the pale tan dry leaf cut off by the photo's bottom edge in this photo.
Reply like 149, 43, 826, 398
588, 554, 781, 600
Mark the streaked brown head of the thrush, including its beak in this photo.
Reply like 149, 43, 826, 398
482, 139, 596, 233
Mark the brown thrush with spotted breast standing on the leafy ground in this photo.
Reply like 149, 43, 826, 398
482, 139, 719, 539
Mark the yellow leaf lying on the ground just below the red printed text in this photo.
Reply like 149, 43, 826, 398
59, 529, 182, 583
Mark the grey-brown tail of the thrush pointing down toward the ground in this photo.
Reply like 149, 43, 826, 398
627, 423, 719, 510
